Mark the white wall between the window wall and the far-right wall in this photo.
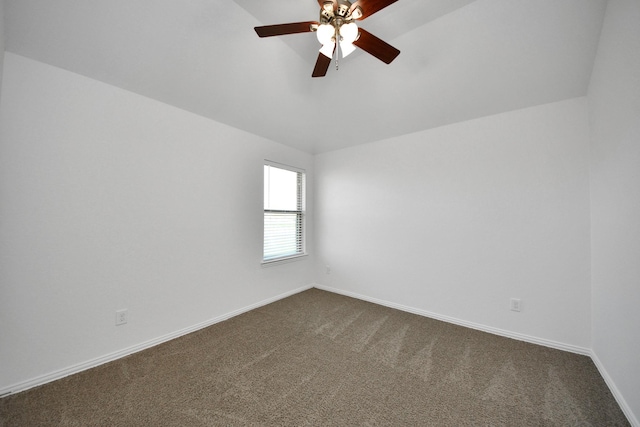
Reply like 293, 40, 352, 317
315, 98, 591, 352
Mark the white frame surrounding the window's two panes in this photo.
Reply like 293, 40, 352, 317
261, 160, 307, 267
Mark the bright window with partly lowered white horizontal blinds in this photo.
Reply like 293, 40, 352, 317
262, 162, 305, 263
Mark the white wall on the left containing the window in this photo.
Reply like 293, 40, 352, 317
0, 53, 313, 391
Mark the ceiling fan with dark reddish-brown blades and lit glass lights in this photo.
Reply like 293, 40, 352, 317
255, 0, 400, 77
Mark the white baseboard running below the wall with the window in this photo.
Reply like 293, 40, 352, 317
0, 285, 313, 398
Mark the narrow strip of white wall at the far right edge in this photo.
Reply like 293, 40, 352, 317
589, 0, 640, 426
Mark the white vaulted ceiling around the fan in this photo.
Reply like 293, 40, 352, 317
4, 0, 606, 153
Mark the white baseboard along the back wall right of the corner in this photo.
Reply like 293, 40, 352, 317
314, 284, 591, 356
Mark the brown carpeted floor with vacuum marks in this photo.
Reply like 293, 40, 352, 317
0, 289, 629, 426
